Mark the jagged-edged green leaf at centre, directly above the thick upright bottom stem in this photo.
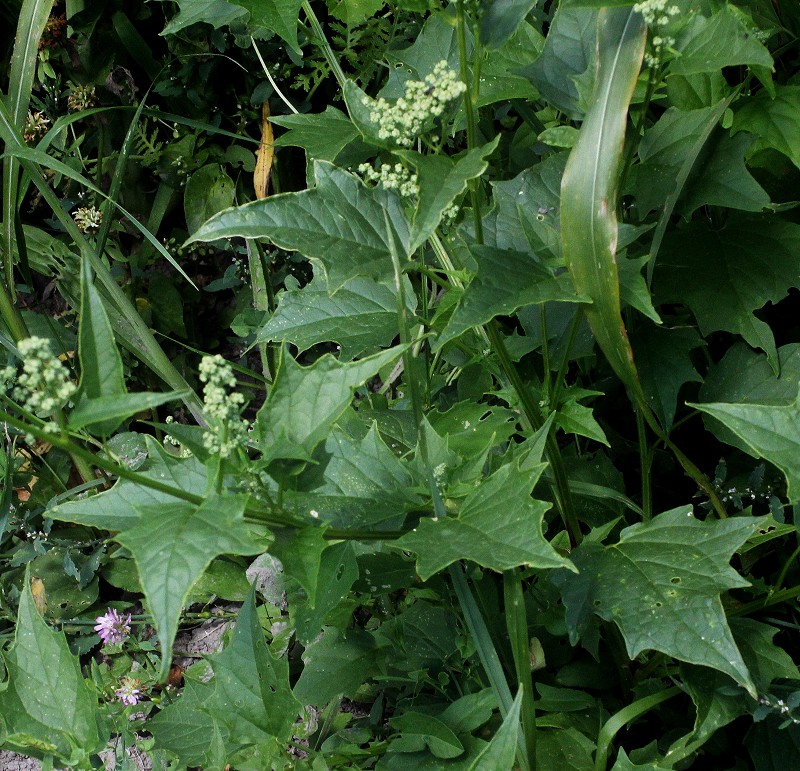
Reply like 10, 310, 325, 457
397, 464, 572, 581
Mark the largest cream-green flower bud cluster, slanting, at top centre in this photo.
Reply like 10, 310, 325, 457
364, 60, 467, 147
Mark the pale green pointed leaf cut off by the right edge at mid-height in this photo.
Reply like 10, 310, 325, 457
689, 392, 800, 503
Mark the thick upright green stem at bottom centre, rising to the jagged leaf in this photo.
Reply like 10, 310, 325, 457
503, 570, 536, 771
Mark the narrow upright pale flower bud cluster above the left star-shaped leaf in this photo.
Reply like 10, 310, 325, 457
200, 355, 249, 458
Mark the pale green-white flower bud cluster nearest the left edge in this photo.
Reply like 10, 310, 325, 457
9, 337, 76, 417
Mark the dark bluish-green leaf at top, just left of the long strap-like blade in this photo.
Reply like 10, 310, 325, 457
520, 7, 597, 120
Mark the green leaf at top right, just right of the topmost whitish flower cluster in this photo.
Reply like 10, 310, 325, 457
670, 5, 772, 75
